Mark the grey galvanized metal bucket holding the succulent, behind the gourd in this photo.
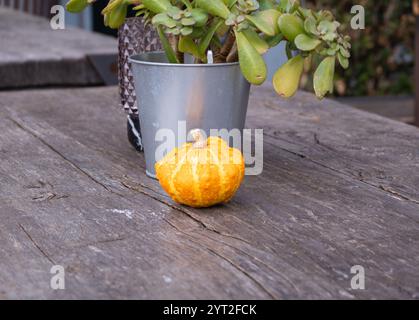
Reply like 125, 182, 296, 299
130, 52, 250, 178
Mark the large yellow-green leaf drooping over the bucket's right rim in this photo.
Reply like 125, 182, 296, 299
235, 31, 268, 85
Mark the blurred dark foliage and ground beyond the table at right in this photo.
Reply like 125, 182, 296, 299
302, 0, 418, 123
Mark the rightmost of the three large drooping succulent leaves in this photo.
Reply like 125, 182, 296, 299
313, 57, 336, 99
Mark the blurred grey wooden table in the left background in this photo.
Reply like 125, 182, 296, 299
0, 7, 118, 89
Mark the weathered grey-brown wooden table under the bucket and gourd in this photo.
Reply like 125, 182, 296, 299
0, 87, 419, 299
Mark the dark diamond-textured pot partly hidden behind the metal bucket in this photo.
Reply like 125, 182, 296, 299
118, 17, 162, 151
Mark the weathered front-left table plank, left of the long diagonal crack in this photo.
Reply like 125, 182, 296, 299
0, 114, 276, 298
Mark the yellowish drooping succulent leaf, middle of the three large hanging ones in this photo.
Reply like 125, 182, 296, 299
272, 55, 304, 98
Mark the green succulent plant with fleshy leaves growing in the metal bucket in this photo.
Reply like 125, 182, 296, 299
67, 0, 351, 98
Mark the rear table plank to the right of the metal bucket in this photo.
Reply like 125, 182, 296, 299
248, 87, 419, 203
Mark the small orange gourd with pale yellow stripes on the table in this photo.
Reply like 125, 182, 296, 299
155, 137, 245, 208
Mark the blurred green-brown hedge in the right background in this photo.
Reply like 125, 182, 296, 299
302, 0, 415, 96
